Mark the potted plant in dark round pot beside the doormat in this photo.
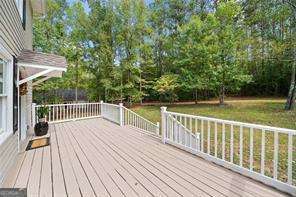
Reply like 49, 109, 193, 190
34, 105, 49, 136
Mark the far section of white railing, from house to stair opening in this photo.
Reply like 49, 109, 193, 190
32, 101, 159, 136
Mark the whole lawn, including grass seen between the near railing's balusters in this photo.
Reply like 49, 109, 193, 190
132, 98, 296, 184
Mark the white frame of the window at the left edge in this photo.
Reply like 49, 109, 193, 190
0, 43, 13, 145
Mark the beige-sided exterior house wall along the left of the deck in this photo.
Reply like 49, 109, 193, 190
0, 0, 33, 187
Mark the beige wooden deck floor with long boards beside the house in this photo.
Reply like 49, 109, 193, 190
6, 118, 286, 197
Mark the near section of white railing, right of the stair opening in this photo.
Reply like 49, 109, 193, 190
161, 107, 296, 195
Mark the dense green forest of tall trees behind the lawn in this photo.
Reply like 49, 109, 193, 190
34, 0, 296, 109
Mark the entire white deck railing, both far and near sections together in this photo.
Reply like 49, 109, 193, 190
32, 102, 296, 195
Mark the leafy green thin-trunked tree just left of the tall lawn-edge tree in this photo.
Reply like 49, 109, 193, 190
176, 15, 217, 102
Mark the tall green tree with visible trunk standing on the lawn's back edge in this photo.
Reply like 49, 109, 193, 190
213, 1, 251, 105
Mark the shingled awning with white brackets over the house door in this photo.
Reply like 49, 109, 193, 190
17, 50, 67, 85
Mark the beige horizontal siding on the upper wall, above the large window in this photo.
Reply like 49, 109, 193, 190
0, 0, 24, 56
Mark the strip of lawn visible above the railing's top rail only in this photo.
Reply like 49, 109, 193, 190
132, 98, 296, 129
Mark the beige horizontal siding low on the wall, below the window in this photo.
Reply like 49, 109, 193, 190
0, 134, 18, 185
